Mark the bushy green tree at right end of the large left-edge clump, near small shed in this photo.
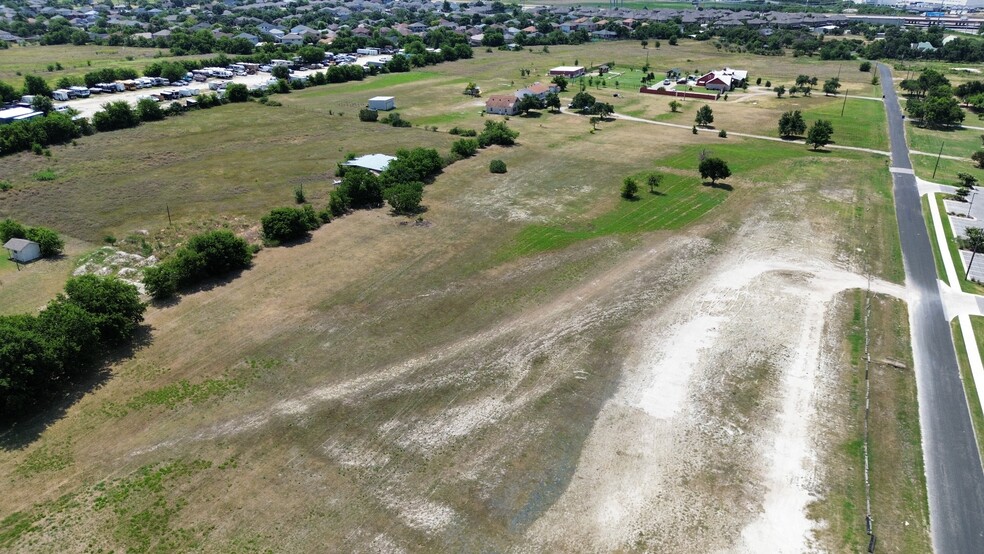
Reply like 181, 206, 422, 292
65, 275, 147, 345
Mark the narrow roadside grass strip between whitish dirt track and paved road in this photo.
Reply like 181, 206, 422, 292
812, 291, 931, 552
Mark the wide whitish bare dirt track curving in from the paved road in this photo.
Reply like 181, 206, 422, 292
528, 224, 905, 553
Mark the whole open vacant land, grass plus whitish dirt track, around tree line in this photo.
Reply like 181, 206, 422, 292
0, 43, 922, 552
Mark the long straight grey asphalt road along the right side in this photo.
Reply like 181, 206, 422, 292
873, 64, 984, 554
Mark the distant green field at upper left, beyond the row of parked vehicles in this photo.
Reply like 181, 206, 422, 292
0, 44, 210, 87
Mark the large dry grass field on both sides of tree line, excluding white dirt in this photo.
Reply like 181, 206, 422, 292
0, 37, 918, 552
